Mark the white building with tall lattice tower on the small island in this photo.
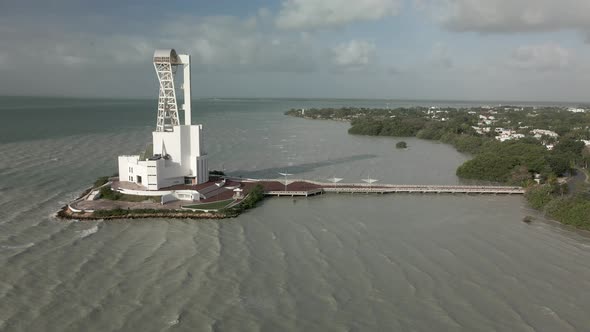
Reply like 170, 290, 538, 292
119, 49, 209, 190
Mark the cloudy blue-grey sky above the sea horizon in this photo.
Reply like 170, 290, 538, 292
0, 0, 590, 102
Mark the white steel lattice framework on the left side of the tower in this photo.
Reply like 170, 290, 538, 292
154, 57, 179, 131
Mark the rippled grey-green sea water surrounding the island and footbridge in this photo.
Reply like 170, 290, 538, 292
0, 98, 590, 331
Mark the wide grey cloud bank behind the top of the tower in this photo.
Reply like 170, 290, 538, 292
0, 16, 318, 72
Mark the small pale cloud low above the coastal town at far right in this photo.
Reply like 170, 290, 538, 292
507, 43, 573, 71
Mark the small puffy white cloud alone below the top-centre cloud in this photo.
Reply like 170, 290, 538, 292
332, 40, 377, 69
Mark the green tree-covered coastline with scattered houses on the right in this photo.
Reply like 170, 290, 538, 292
287, 108, 590, 230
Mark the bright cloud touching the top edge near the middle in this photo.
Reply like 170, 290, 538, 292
276, 0, 401, 29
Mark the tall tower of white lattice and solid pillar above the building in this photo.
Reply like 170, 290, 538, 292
154, 49, 191, 131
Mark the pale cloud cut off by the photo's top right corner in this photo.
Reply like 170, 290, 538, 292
432, 0, 590, 33
